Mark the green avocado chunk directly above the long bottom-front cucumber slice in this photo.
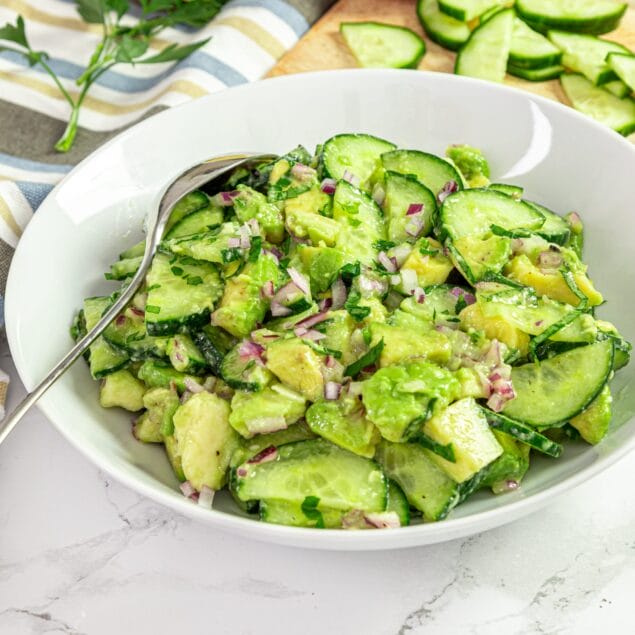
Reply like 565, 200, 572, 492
306, 400, 381, 459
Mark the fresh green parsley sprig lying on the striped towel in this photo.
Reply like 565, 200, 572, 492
0, 0, 226, 152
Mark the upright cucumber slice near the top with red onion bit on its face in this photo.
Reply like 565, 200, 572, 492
383, 171, 437, 243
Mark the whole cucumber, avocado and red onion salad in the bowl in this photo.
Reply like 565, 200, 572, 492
72, 134, 631, 528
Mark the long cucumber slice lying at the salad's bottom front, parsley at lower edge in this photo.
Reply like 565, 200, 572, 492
235, 439, 387, 512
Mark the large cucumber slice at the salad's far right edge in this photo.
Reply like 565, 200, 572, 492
503, 340, 614, 428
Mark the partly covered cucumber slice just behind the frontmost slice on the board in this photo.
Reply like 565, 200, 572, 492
548, 31, 630, 86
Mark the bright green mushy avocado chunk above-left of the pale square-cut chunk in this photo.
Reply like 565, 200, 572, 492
362, 361, 460, 442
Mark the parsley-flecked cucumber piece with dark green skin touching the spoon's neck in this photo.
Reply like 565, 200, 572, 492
145, 253, 223, 335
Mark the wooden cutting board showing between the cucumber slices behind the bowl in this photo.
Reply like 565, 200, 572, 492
269, 0, 635, 140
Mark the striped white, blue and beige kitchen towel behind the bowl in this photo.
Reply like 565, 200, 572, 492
0, 0, 334, 302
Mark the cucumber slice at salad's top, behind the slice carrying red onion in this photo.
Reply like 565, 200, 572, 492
381, 150, 463, 197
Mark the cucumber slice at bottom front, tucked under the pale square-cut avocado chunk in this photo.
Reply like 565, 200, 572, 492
376, 441, 460, 521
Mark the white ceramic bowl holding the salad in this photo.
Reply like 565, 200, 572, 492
6, 70, 635, 550
